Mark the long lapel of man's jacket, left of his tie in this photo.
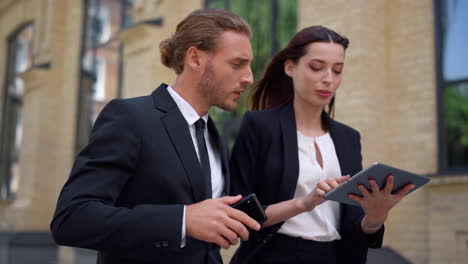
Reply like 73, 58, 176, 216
153, 84, 207, 202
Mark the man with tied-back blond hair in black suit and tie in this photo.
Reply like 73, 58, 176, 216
51, 9, 260, 264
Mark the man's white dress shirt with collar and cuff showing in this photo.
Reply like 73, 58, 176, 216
167, 86, 224, 247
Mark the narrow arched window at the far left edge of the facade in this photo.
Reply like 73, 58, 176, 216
0, 24, 34, 200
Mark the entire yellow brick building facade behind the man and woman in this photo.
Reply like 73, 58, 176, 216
0, 0, 468, 264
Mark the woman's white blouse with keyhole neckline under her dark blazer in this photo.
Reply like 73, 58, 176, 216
278, 131, 342, 242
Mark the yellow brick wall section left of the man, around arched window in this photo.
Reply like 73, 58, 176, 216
0, 0, 81, 231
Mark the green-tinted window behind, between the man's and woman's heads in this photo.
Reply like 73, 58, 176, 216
205, 0, 297, 146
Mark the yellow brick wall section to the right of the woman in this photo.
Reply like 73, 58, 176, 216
298, 0, 468, 264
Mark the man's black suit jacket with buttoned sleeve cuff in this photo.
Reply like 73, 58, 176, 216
51, 84, 229, 264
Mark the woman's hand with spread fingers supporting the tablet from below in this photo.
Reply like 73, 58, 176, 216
349, 175, 415, 233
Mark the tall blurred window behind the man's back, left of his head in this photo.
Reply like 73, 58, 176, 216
76, 0, 134, 151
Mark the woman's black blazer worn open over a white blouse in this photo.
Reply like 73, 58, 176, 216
230, 102, 383, 264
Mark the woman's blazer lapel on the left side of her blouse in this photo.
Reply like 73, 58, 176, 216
279, 102, 299, 201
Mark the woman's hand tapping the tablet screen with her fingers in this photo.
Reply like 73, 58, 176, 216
300, 175, 349, 212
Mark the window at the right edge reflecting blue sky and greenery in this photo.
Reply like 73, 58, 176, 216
434, 0, 468, 173
